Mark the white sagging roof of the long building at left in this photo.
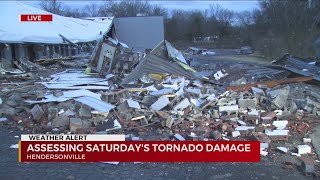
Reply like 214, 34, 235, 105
0, 1, 113, 44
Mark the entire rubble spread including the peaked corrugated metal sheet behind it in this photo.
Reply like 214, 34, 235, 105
0, 41, 320, 172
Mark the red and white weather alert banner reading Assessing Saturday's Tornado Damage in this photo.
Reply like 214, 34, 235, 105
19, 134, 260, 162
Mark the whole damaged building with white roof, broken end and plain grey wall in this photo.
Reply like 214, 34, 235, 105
0, 1, 164, 74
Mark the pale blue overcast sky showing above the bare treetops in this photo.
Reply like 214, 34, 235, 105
22, 0, 258, 12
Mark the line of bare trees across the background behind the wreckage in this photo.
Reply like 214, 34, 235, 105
40, 0, 320, 59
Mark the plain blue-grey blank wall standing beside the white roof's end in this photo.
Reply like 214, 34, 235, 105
114, 16, 164, 52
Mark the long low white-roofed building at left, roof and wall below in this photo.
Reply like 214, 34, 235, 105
0, 1, 114, 69
